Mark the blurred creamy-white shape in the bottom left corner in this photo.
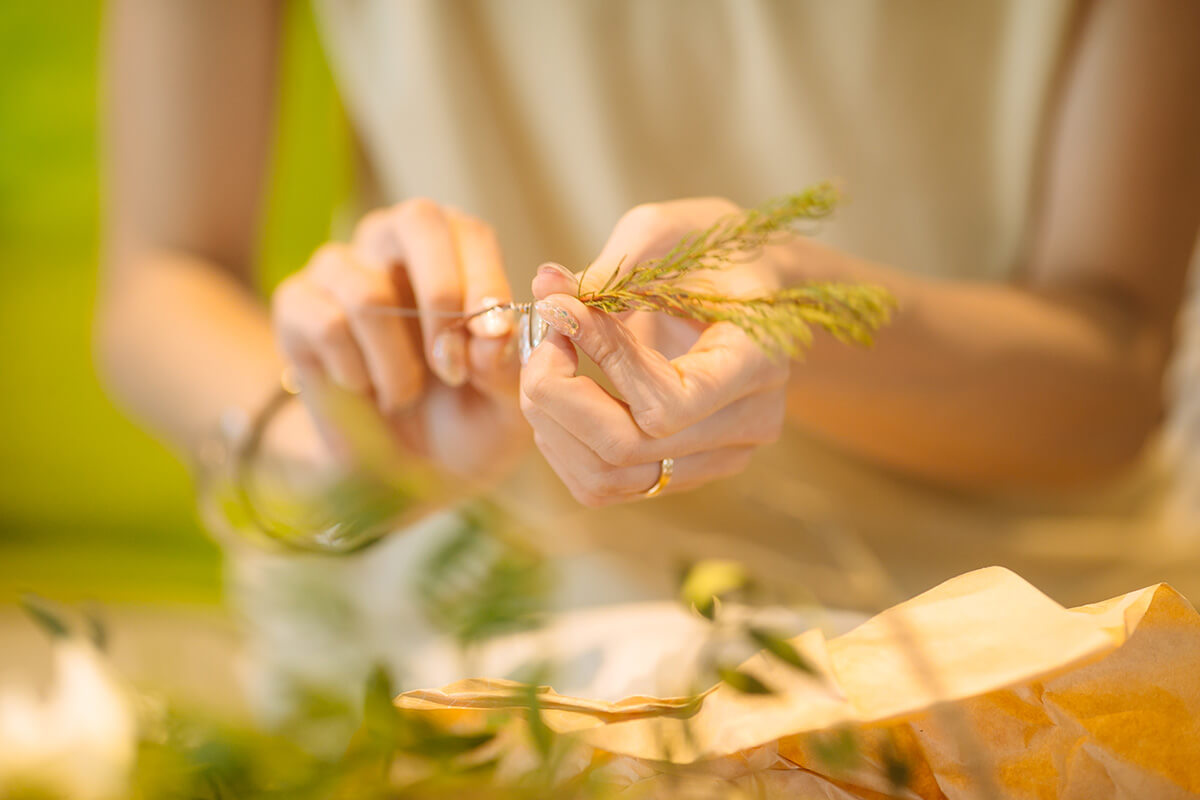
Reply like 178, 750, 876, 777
0, 639, 137, 800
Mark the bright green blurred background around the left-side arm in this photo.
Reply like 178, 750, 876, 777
0, 1, 352, 603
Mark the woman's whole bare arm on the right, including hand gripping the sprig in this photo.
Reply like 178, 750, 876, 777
522, 0, 1200, 505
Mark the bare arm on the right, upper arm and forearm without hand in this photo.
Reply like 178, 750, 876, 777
778, 0, 1200, 488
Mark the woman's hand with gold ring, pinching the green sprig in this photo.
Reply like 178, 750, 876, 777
521, 199, 788, 506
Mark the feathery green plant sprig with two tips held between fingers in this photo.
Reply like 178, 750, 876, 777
578, 182, 895, 357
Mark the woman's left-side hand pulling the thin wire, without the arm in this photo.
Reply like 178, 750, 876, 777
272, 199, 529, 480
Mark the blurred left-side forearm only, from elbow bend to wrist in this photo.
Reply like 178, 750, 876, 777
96, 251, 289, 451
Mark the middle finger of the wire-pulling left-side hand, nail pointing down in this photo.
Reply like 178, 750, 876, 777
354, 199, 468, 386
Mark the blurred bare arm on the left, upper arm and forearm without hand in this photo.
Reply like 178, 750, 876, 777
96, 0, 283, 451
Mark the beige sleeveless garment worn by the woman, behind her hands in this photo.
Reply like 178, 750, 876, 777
319, 0, 1200, 606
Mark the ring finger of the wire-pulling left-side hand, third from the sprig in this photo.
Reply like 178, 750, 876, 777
308, 245, 425, 414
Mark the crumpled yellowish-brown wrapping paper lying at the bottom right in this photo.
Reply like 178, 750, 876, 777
396, 567, 1200, 800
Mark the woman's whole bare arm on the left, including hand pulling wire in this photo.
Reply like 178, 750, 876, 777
96, 0, 529, 487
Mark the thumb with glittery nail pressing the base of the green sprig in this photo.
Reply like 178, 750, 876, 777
534, 291, 682, 435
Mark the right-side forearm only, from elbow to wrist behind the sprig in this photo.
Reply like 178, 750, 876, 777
791, 237, 1166, 487
